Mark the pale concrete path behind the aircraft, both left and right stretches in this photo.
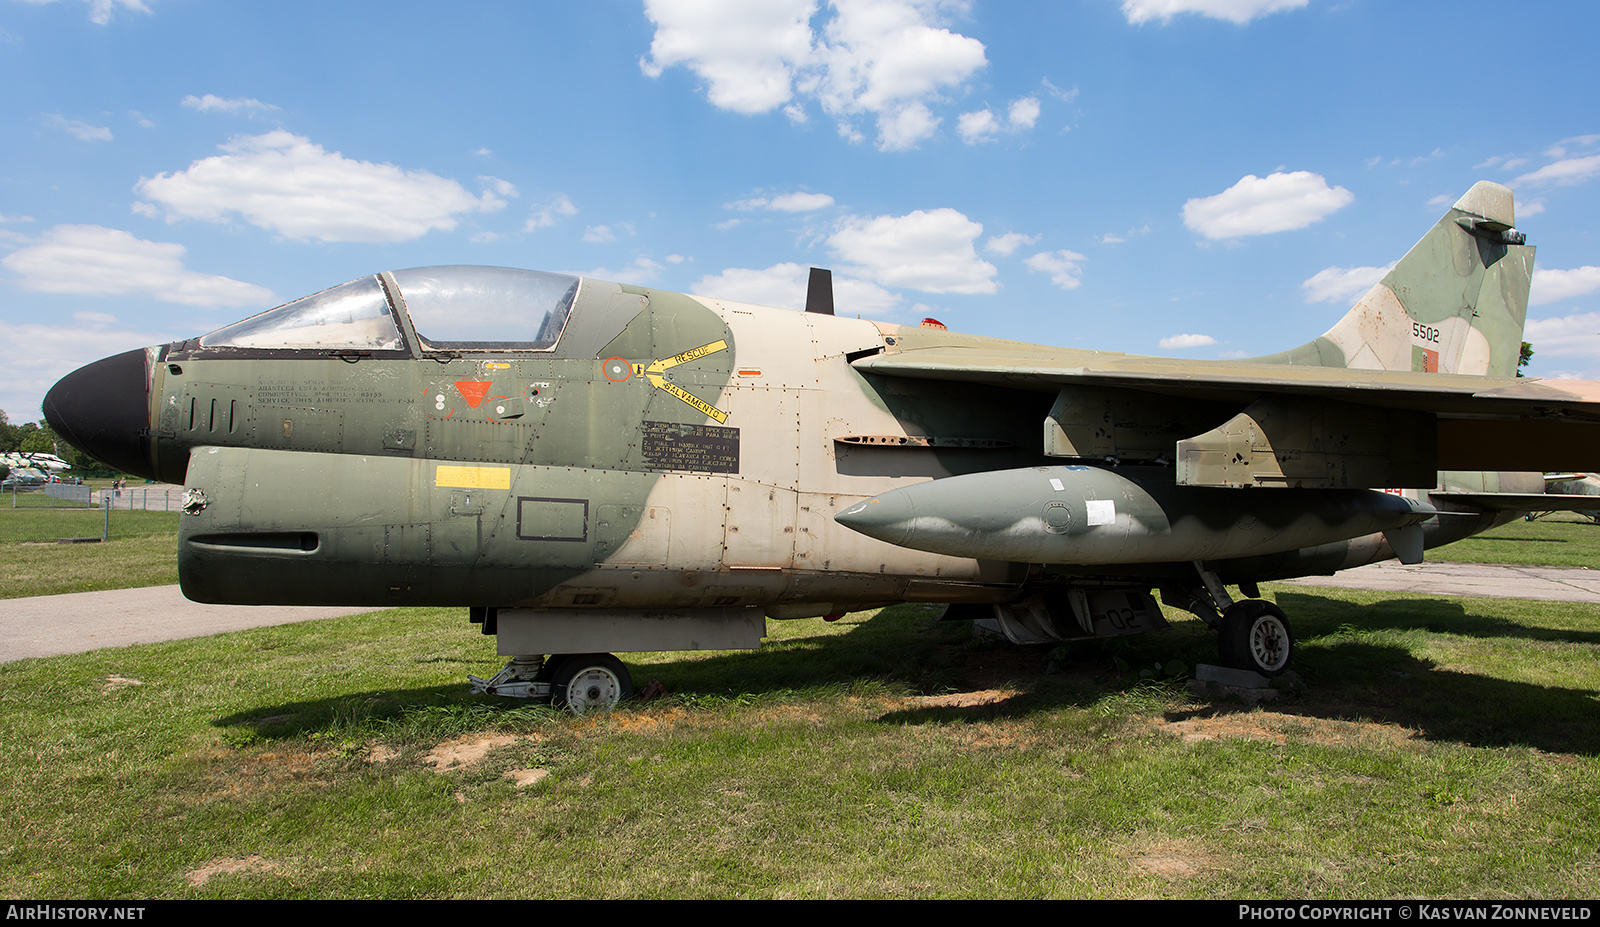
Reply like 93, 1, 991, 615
0, 562, 1600, 663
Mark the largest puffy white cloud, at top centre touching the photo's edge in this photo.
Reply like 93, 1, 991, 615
640, 0, 989, 150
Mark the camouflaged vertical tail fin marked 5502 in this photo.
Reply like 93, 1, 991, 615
1256, 181, 1534, 376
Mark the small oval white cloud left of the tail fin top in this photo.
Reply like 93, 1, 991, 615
1184, 171, 1355, 239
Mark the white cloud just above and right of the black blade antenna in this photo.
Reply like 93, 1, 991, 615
827, 208, 998, 293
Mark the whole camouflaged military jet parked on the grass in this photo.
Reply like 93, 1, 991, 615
45, 183, 1600, 709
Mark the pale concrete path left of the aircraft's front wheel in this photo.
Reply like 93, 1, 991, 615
0, 586, 378, 663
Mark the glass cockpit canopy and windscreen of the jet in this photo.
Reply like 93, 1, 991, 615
200, 266, 579, 351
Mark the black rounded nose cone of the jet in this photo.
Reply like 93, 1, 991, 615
45, 347, 155, 479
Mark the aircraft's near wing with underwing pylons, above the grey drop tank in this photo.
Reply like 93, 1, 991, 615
853, 344, 1600, 488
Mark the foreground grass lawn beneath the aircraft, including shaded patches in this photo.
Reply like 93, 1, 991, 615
0, 586, 1600, 898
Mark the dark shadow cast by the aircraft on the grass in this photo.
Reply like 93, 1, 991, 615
216, 592, 1600, 756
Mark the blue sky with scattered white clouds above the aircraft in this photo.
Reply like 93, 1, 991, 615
0, 0, 1600, 423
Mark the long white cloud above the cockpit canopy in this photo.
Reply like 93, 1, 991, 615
134, 130, 506, 242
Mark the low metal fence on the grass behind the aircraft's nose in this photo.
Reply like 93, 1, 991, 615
0, 484, 184, 544
